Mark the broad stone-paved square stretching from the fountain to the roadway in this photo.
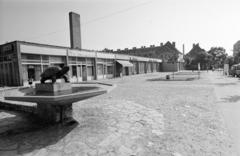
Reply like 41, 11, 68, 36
0, 73, 234, 156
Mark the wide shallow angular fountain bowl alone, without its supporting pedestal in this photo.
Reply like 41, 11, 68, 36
5, 86, 107, 105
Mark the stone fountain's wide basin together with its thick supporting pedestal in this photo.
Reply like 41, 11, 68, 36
2, 83, 107, 123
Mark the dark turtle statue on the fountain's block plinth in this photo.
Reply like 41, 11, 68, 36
41, 66, 69, 83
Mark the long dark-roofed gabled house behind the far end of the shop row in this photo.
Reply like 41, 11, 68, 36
114, 41, 184, 72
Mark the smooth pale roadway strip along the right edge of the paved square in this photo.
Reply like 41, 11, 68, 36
209, 72, 240, 155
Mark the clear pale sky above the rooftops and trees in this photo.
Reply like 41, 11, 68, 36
0, 0, 240, 55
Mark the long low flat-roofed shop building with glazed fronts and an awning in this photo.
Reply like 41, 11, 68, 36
0, 41, 162, 86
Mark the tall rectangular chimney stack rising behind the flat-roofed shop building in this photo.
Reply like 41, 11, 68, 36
69, 12, 82, 49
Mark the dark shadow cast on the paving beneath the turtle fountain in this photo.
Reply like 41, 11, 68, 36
0, 111, 78, 155
